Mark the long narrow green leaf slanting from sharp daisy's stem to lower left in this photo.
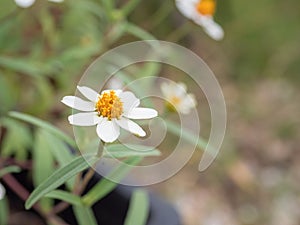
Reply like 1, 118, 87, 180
25, 156, 98, 209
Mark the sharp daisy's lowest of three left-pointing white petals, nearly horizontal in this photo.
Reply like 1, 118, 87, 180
68, 112, 103, 126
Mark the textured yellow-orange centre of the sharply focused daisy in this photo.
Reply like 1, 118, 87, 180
95, 91, 123, 120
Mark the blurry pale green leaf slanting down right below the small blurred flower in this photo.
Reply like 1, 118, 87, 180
165, 119, 207, 150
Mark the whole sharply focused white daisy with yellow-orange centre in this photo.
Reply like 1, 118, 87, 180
62, 86, 157, 142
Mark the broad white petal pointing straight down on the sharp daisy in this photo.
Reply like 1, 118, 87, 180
97, 119, 120, 143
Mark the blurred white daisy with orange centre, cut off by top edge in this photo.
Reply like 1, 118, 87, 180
176, 0, 224, 40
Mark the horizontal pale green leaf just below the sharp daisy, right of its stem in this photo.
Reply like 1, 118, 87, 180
103, 144, 161, 158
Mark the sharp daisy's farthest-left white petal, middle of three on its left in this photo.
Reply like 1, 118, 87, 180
61, 96, 95, 112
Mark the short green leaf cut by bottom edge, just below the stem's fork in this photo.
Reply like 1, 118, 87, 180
73, 206, 97, 225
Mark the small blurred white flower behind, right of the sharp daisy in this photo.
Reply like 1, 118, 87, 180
161, 82, 197, 114
